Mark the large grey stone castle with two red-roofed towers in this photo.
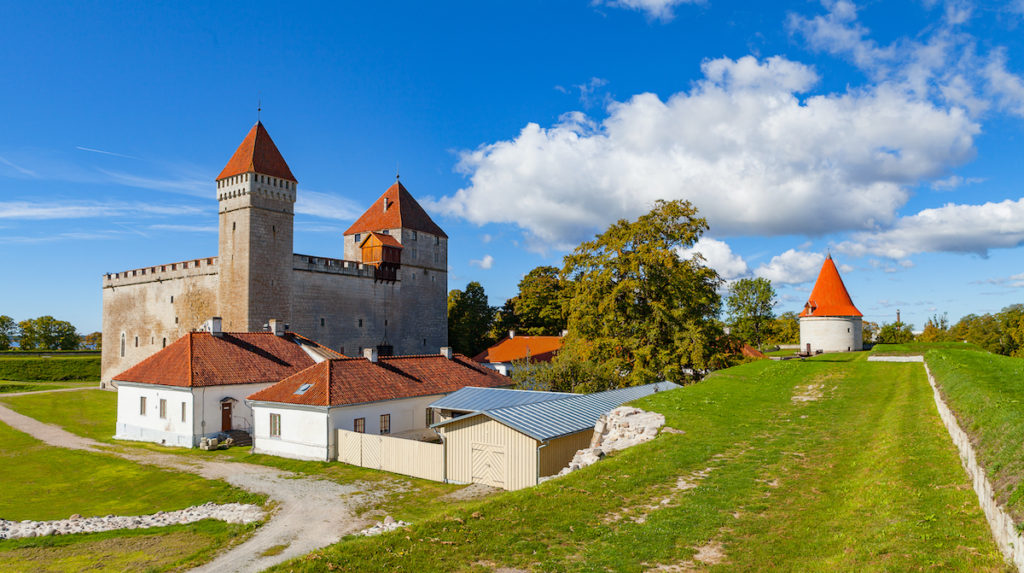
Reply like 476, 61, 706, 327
101, 122, 447, 386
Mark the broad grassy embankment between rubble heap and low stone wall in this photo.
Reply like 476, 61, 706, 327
266, 354, 1007, 571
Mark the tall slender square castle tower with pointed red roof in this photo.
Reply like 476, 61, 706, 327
217, 122, 297, 332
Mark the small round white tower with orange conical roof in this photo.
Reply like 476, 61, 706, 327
800, 254, 863, 354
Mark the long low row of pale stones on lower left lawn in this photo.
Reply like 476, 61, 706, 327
0, 502, 263, 539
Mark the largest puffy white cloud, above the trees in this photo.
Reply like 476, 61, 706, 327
432, 56, 979, 248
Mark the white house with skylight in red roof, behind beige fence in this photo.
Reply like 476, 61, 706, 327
248, 348, 511, 460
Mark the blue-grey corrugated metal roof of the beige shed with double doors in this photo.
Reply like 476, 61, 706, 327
434, 382, 679, 442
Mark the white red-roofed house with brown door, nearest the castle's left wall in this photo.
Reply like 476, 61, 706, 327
114, 319, 340, 447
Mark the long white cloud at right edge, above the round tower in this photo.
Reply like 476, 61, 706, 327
837, 199, 1024, 259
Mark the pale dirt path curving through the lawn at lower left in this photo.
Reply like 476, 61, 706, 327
0, 399, 374, 573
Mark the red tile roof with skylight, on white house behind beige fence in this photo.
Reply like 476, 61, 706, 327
249, 354, 512, 406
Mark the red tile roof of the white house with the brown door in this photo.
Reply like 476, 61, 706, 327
114, 333, 341, 388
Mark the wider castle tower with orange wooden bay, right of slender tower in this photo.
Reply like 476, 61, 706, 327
344, 181, 447, 354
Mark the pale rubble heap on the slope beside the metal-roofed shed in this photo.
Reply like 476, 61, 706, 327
542, 406, 665, 479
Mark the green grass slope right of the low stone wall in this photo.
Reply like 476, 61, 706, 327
925, 348, 1024, 529
